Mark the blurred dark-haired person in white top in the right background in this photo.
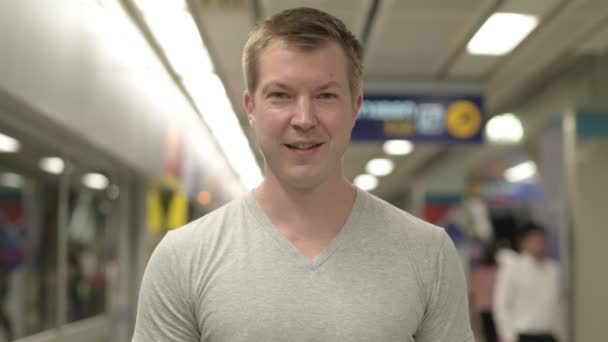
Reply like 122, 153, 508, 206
494, 223, 561, 342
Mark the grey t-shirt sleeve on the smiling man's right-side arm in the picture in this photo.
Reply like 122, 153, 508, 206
415, 232, 475, 342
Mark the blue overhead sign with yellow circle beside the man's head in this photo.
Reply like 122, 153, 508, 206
352, 95, 485, 143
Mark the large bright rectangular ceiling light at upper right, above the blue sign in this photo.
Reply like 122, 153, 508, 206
467, 12, 538, 55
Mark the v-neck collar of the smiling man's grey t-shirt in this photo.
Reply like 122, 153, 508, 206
245, 187, 365, 270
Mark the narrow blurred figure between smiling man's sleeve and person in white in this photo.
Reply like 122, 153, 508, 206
470, 246, 498, 342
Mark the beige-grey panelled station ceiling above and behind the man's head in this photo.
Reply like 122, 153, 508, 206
189, 0, 608, 201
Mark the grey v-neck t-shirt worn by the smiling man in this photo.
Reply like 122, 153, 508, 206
133, 190, 474, 342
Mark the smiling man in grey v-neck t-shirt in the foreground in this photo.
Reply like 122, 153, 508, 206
133, 8, 473, 342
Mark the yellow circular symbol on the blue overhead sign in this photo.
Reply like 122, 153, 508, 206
445, 100, 481, 139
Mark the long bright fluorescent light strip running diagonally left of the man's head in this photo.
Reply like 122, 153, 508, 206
136, 0, 262, 189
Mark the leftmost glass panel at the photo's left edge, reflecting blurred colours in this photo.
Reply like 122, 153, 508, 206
0, 166, 58, 341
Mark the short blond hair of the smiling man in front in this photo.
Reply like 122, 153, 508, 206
242, 7, 363, 99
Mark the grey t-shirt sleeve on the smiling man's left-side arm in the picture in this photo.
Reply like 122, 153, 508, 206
132, 232, 200, 342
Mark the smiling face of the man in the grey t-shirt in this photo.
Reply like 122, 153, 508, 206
244, 41, 361, 189
